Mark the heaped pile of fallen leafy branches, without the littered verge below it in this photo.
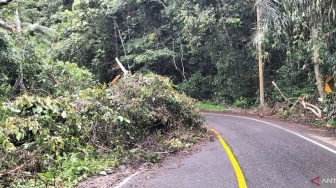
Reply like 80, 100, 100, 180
0, 70, 204, 186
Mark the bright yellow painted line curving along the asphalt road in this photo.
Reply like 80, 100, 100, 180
212, 128, 247, 188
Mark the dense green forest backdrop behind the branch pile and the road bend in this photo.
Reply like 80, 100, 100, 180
0, 0, 335, 105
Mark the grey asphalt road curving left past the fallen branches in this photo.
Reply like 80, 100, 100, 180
117, 114, 336, 188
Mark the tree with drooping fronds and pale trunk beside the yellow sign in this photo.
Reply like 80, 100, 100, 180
257, 0, 335, 97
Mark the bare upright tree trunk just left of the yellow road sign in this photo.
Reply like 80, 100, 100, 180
313, 28, 324, 98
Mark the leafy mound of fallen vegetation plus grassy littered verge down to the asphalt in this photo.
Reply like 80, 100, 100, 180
0, 73, 207, 187
